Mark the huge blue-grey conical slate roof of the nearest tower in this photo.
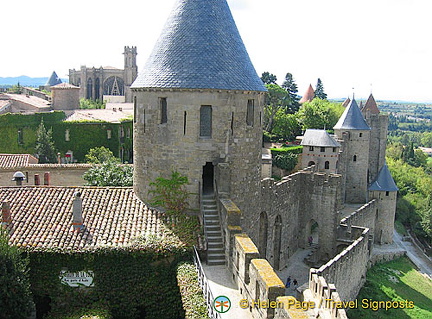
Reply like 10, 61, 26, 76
132, 0, 267, 91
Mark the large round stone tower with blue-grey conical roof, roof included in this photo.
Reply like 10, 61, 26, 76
132, 0, 266, 213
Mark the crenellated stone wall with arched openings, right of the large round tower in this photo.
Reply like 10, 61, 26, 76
256, 168, 342, 269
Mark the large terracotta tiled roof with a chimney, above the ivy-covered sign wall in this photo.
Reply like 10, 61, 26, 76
0, 186, 176, 251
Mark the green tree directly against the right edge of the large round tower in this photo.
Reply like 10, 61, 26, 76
264, 84, 290, 133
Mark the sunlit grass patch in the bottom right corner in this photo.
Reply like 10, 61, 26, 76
348, 257, 432, 319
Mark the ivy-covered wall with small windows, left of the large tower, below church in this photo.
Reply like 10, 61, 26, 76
0, 111, 133, 162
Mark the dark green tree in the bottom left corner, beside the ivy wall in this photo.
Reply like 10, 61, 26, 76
0, 229, 34, 319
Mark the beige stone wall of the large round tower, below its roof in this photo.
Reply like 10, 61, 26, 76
134, 89, 264, 213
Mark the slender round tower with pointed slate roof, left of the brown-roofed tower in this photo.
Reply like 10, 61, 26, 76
333, 98, 371, 203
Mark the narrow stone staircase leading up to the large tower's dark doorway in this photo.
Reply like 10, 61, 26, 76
201, 195, 225, 265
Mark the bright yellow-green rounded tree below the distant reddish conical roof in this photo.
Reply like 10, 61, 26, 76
297, 98, 344, 129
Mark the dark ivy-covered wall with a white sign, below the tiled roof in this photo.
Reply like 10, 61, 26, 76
30, 249, 190, 319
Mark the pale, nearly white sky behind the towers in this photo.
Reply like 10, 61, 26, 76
0, 0, 432, 101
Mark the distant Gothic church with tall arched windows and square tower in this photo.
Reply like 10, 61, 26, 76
69, 46, 138, 103
